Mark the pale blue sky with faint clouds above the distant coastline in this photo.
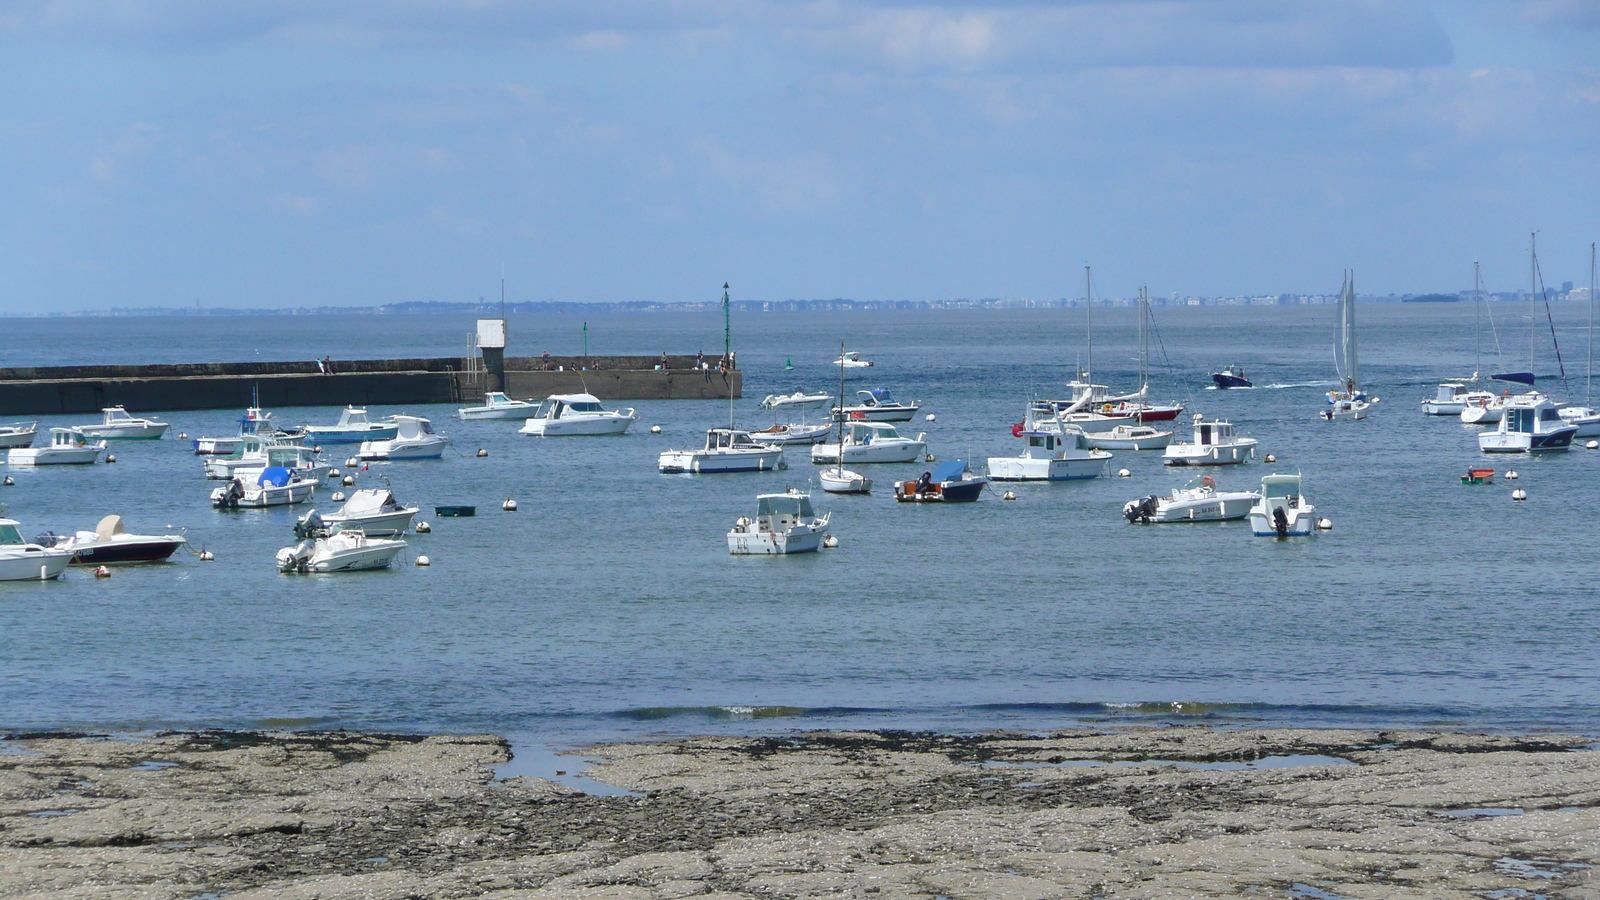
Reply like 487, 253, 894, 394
0, 0, 1600, 314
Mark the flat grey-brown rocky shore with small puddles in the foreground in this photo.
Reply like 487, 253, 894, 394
0, 727, 1600, 900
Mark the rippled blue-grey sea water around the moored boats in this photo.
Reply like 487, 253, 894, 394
0, 304, 1600, 743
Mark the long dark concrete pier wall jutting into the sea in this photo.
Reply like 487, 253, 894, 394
0, 356, 742, 420
